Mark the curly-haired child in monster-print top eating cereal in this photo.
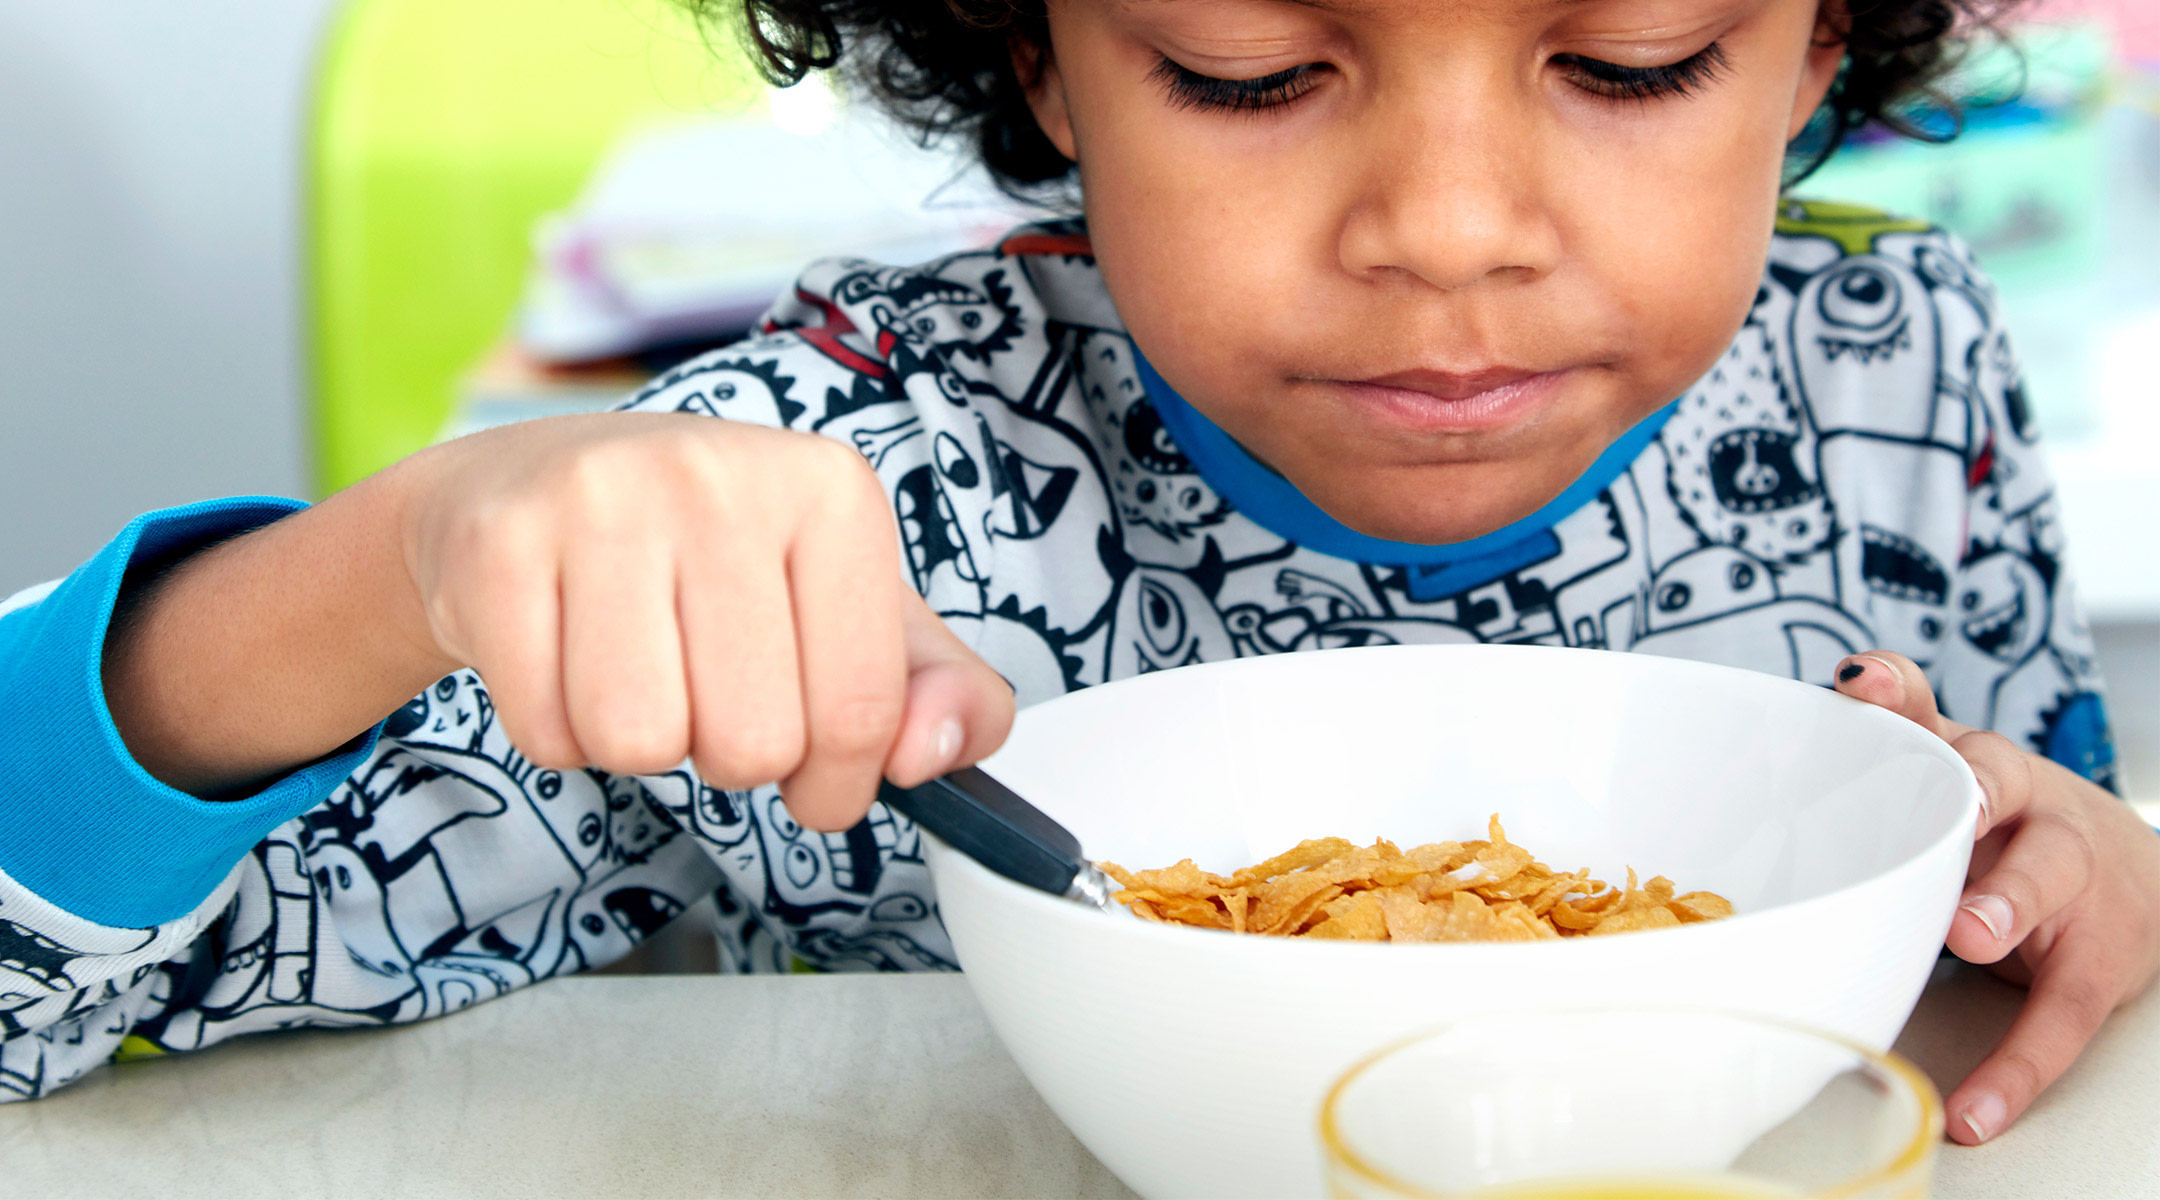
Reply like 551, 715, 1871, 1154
0, 0, 2160, 1142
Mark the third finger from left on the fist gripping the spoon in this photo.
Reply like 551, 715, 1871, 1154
676, 529, 806, 788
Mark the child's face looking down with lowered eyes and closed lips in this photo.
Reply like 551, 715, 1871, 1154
1032, 0, 1840, 542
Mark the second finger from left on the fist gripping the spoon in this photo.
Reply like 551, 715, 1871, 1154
562, 522, 689, 775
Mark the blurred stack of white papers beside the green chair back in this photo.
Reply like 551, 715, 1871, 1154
516, 82, 1030, 363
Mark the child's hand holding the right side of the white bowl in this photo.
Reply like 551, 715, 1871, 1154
1838, 652, 2160, 1146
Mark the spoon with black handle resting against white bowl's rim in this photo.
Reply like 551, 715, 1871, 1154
877, 766, 1121, 913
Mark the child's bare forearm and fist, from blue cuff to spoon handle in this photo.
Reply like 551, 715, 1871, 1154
104, 412, 1011, 829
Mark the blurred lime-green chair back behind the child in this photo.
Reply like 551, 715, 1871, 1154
307, 0, 762, 492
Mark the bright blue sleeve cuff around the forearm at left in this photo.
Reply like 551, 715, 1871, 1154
0, 496, 380, 928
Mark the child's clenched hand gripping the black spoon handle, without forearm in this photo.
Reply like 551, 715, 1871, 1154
400, 412, 1013, 831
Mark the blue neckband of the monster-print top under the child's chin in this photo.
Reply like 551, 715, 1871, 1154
1132, 347, 1678, 596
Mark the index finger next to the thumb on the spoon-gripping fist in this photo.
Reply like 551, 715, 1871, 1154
780, 442, 907, 831
